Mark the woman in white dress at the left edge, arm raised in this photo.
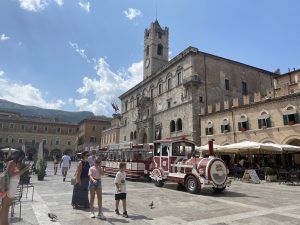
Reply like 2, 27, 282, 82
0, 150, 29, 225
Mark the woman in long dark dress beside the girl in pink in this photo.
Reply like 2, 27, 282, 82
72, 151, 90, 209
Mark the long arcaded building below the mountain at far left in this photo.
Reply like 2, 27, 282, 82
0, 112, 78, 157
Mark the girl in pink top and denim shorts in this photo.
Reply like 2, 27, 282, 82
89, 157, 106, 220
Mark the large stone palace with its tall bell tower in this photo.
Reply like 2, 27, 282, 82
119, 21, 274, 144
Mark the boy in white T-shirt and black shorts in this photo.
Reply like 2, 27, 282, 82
114, 162, 128, 218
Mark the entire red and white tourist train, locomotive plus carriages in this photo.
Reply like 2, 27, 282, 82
100, 138, 230, 193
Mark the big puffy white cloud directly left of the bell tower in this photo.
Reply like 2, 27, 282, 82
74, 58, 143, 116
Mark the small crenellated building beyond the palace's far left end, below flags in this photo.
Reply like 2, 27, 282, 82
101, 114, 121, 149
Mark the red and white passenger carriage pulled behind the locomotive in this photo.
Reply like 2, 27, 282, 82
101, 144, 153, 179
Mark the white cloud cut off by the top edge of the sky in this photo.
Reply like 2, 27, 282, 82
19, 0, 64, 12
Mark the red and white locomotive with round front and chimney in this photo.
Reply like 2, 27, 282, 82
150, 139, 230, 193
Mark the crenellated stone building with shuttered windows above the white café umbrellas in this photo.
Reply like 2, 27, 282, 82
200, 70, 300, 146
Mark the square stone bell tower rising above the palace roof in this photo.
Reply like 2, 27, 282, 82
143, 20, 169, 79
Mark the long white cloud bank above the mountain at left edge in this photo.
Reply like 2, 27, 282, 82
0, 70, 65, 109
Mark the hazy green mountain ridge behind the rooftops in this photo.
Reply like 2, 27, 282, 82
0, 99, 95, 124
